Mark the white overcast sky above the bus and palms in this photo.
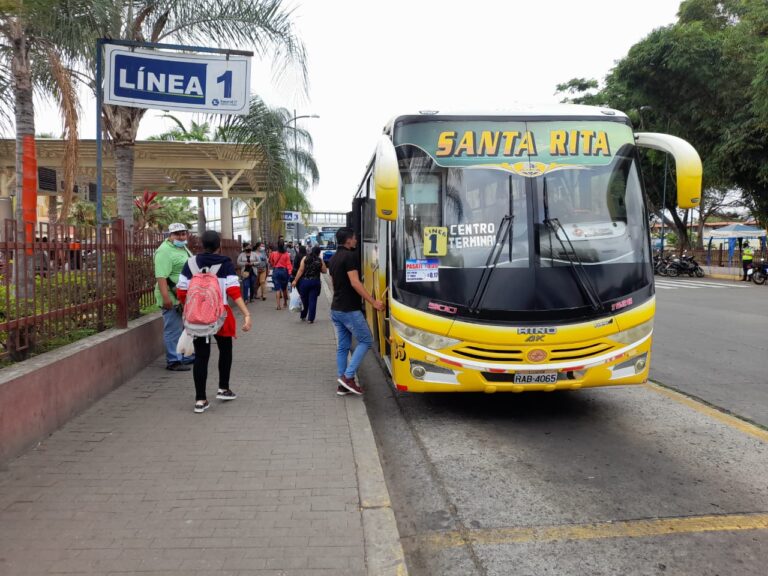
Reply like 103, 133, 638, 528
30, 0, 680, 212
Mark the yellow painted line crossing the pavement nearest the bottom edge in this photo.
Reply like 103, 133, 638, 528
403, 513, 768, 550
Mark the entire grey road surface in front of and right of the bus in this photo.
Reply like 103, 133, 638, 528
360, 279, 768, 576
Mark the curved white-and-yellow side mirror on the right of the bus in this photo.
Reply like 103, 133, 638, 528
635, 132, 701, 208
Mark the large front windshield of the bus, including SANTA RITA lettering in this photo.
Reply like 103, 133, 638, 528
393, 120, 652, 321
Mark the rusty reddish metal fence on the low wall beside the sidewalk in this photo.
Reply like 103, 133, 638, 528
0, 220, 241, 361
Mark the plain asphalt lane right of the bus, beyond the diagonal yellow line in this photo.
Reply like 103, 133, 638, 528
651, 278, 768, 428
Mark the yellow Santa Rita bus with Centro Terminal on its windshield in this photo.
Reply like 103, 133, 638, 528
348, 105, 701, 393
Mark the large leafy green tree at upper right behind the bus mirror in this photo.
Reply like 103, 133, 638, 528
558, 0, 768, 238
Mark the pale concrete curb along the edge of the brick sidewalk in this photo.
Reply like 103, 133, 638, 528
323, 280, 408, 576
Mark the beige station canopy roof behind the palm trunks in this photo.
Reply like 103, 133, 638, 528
0, 138, 267, 198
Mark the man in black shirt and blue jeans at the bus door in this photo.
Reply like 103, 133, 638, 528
329, 228, 384, 396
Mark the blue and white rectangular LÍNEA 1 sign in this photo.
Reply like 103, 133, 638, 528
104, 44, 251, 114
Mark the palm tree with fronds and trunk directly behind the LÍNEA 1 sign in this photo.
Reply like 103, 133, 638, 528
76, 0, 307, 230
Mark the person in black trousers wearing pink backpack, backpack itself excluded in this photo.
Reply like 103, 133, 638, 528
178, 230, 251, 413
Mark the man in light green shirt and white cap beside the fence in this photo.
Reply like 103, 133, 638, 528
155, 222, 194, 371
